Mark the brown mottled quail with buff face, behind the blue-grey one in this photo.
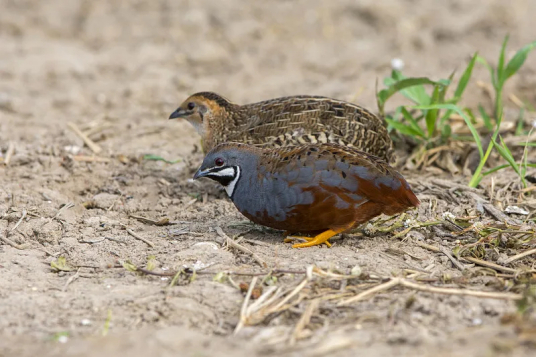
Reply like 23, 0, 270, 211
169, 92, 395, 162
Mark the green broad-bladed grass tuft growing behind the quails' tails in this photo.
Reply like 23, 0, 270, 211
376, 36, 536, 188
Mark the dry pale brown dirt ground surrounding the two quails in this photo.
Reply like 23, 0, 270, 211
0, 0, 536, 357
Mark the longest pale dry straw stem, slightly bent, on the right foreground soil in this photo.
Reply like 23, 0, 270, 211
338, 278, 523, 306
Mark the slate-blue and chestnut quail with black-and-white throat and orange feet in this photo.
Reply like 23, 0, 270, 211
193, 142, 420, 248
